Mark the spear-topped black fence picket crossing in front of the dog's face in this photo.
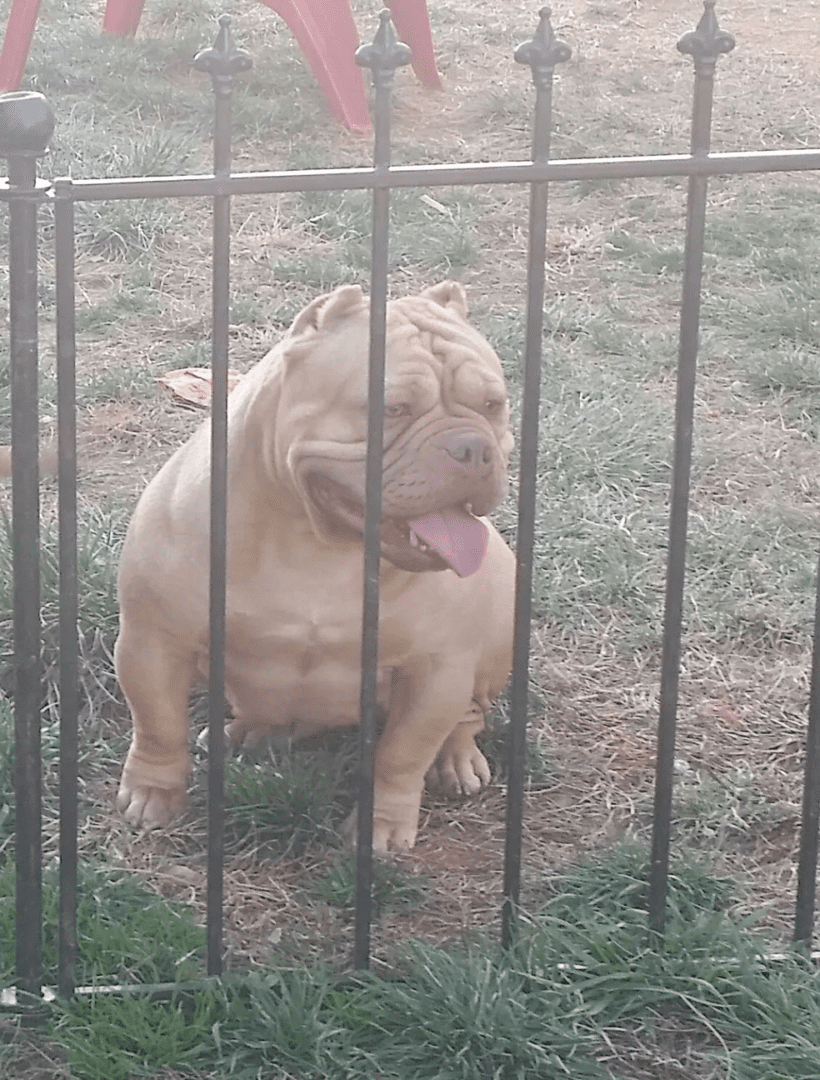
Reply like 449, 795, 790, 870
353, 9, 411, 970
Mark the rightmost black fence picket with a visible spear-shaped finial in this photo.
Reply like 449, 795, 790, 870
648, 0, 735, 935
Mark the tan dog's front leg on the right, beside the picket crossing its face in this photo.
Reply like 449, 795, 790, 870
350, 656, 475, 854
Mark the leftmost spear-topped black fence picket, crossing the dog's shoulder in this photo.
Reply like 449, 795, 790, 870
194, 15, 251, 975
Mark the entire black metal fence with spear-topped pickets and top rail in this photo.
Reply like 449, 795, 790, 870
0, 0, 820, 1000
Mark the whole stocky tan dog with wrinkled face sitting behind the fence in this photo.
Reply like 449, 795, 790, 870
116, 282, 514, 852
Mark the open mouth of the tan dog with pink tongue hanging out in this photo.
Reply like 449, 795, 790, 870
309, 477, 488, 578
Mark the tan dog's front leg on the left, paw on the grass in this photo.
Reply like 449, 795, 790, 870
115, 622, 196, 828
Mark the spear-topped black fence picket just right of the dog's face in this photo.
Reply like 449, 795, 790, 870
501, 8, 572, 946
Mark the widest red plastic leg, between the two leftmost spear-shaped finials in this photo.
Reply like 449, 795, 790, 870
261, 0, 371, 132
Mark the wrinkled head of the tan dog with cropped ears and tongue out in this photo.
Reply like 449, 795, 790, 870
269, 282, 512, 576
